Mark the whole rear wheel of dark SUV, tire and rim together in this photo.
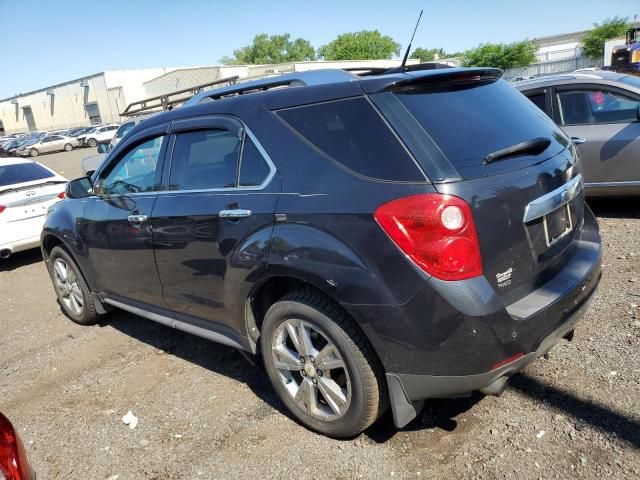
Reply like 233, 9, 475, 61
260, 289, 388, 438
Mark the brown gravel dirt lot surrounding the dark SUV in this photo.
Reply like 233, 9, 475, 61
0, 149, 640, 480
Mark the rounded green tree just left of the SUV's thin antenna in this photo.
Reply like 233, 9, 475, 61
318, 30, 400, 60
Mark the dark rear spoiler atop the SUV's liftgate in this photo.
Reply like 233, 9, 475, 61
361, 68, 504, 93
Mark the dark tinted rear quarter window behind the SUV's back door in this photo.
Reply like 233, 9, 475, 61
278, 98, 424, 181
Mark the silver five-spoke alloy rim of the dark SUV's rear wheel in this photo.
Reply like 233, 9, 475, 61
271, 319, 352, 421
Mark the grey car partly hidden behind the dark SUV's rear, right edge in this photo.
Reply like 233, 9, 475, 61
515, 71, 640, 196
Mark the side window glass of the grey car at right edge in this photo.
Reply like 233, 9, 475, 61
558, 90, 639, 125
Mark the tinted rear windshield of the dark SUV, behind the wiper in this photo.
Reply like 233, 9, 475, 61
395, 80, 568, 178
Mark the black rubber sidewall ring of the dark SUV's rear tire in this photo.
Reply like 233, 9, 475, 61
261, 301, 366, 438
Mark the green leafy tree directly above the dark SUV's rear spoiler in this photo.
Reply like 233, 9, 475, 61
462, 40, 538, 69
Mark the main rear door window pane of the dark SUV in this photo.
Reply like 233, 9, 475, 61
169, 130, 240, 190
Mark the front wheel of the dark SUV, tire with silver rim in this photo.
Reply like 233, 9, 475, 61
49, 247, 99, 325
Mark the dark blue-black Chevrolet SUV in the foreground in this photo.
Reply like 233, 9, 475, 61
42, 68, 601, 437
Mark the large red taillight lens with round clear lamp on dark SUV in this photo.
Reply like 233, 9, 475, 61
375, 193, 482, 280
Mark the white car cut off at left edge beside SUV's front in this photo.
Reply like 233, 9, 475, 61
0, 158, 67, 259
